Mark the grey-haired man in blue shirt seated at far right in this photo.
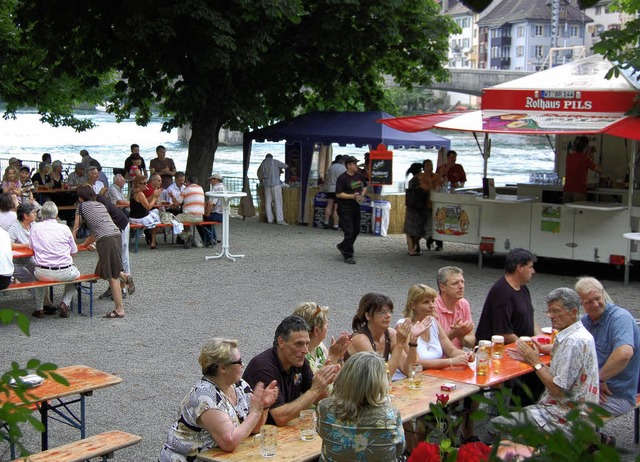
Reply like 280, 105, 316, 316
575, 277, 640, 416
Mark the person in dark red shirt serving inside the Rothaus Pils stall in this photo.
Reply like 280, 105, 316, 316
563, 135, 600, 203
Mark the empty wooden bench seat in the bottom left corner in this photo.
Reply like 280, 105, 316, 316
14, 430, 142, 462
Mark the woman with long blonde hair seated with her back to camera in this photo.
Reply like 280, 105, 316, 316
318, 352, 404, 462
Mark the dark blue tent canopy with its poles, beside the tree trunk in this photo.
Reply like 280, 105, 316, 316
243, 111, 451, 221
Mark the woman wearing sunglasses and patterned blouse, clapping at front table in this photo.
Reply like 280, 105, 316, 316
159, 338, 278, 462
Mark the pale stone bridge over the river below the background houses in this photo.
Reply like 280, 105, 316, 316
386, 68, 532, 96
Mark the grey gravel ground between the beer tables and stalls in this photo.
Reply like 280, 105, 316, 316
0, 218, 640, 461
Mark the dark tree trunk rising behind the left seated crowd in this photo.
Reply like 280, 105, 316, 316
186, 108, 221, 186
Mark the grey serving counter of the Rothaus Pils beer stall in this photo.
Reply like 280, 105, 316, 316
431, 184, 640, 264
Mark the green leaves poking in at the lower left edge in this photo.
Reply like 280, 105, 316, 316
0, 309, 69, 455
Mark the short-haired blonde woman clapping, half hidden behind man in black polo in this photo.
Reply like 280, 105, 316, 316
293, 302, 351, 374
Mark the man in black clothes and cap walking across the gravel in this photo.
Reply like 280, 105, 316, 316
336, 156, 367, 265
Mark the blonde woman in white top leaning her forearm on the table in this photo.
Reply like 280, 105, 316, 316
393, 284, 468, 380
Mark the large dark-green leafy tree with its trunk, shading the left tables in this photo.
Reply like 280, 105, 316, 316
0, 0, 457, 175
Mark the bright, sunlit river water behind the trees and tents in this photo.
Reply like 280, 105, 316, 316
0, 110, 554, 192
